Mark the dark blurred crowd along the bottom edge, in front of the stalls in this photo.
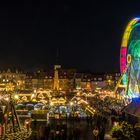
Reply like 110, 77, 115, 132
29, 114, 116, 140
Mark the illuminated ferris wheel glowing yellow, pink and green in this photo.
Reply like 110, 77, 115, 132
120, 18, 140, 97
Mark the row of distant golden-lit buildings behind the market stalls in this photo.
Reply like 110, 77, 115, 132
0, 66, 120, 92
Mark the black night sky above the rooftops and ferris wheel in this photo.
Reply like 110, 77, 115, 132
0, 0, 140, 72
